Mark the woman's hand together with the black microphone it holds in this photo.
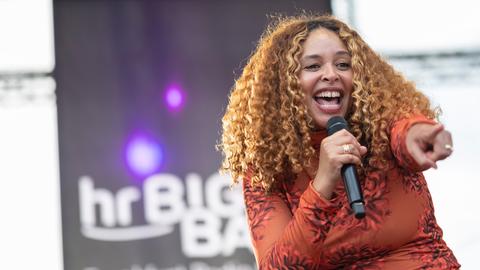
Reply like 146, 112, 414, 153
313, 116, 367, 218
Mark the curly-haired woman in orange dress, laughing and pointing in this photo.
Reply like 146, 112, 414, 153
221, 15, 460, 269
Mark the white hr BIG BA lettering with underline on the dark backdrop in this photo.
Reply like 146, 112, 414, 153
78, 173, 249, 258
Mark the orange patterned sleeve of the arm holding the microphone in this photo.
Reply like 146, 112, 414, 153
243, 176, 338, 269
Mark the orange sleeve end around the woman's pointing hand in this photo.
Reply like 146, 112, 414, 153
390, 115, 436, 172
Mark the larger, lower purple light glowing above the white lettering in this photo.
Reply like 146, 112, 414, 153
126, 137, 163, 176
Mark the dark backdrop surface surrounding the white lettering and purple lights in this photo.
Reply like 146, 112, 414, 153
54, 0, 331, 270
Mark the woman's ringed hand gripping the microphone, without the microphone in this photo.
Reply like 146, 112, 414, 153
313, 130, 367, 199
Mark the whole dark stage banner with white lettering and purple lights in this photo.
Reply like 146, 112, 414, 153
54, 0, 330, 270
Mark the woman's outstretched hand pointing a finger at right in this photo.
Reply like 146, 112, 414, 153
406, 123, 453, 170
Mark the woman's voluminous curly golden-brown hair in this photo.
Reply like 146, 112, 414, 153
219, 14, 435, 191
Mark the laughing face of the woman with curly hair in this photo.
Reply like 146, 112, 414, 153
300, 28, 353, 128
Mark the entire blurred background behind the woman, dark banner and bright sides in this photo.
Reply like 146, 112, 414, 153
0, 0, 480, 270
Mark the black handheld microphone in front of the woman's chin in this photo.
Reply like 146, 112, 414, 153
327, 116, 365, 219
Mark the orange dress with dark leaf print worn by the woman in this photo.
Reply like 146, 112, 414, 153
243, 116, 460, 270
